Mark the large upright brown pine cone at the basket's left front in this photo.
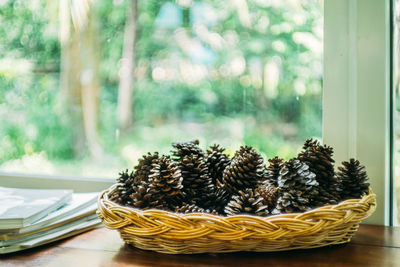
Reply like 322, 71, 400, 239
148, 156, 183, 210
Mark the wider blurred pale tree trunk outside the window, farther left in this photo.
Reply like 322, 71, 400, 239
59, 0, 103, 159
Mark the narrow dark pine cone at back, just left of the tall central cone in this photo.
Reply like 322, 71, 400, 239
206, 145, 230, 188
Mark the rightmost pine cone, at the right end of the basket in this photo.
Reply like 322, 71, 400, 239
337, 159, 369, 200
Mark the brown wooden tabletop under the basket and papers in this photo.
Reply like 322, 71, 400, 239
0, 225, 400, 267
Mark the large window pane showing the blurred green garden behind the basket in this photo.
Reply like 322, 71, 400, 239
0, 0, 323, 177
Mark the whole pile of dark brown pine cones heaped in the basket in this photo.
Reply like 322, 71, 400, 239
117, 139, 369, 216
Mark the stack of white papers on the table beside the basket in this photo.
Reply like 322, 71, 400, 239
0, 187, 100, 254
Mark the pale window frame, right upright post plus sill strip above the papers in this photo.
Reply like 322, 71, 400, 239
0, 0, 392, 225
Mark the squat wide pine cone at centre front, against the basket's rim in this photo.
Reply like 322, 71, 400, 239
225, 188, 269, 216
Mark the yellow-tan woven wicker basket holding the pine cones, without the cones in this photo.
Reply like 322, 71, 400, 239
97, 185, 376, 254
